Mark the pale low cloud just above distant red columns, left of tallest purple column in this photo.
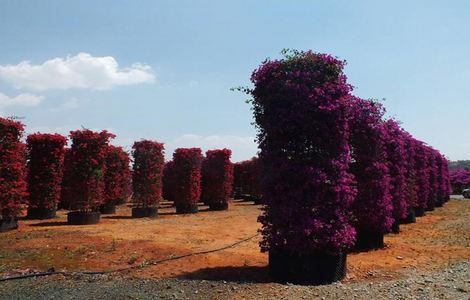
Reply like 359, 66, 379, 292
165, 134, 258, 161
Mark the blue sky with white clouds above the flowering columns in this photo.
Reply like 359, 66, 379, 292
0, 0, 470, 160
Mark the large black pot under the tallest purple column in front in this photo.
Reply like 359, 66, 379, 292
269, 251, 347, 285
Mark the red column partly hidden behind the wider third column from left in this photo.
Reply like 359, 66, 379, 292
103, 145, 131, 206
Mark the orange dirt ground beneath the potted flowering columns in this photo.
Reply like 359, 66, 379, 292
0, 200, 470, 282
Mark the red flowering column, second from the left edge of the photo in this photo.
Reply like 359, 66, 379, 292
27, 133, 67, 211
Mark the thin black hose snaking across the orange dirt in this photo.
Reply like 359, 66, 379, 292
0, 233, 259, 282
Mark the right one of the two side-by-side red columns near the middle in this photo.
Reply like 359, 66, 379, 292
201, 149, 233, 209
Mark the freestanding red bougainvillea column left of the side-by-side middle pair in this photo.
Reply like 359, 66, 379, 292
132, 140, 165, 207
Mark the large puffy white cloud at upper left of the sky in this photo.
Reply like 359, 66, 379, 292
0, 53, 155, 91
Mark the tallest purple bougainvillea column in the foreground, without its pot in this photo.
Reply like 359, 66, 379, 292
248, 51, 355, 255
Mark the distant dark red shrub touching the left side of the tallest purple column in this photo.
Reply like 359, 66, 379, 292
233, 157, 261, 199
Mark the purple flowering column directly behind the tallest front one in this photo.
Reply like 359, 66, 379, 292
350, 98, 392, 233
